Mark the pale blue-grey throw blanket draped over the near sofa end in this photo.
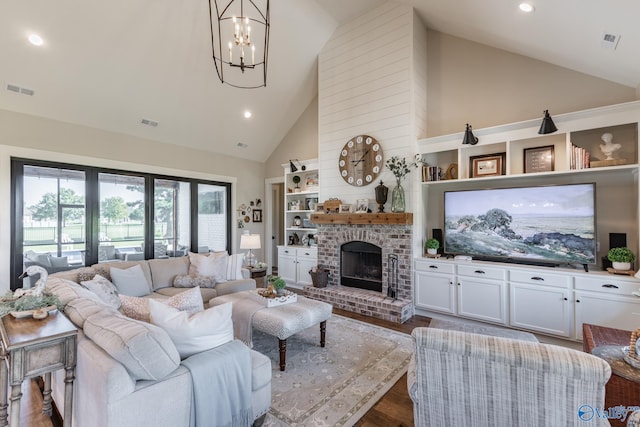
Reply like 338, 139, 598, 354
182, 340, 253, 427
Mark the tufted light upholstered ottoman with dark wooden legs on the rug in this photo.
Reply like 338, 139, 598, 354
209, 290, 333, 371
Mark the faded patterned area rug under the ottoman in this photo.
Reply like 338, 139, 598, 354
253, 314, 413, 427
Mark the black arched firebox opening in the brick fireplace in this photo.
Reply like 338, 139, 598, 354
340, 241, 382, 292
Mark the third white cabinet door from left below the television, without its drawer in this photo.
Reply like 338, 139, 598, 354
509, 283, 573, 337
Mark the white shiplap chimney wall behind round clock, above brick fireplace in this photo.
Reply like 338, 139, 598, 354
318, 2, 427, 320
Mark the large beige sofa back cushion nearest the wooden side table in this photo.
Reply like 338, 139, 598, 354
84, 305, 180, 380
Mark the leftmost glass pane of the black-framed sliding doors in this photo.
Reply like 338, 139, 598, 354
20, 165, 86, 282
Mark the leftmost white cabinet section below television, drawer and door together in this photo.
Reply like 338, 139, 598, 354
414, 258, 456, 314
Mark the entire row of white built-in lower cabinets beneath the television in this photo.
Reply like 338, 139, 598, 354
414, 258, 640, 340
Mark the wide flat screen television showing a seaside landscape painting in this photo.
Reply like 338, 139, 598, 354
444, 183, 596, 265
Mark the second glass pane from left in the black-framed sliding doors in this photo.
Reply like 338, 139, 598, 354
98, 173, 145, 262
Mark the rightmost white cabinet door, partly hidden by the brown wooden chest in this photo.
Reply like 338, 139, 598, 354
575, 291, 640, 340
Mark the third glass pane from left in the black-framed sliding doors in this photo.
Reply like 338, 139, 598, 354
153, 179, 191, 258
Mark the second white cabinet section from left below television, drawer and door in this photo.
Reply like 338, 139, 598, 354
457, 264, 507, 325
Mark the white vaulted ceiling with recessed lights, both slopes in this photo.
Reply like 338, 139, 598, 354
0, 0, 640, 161
